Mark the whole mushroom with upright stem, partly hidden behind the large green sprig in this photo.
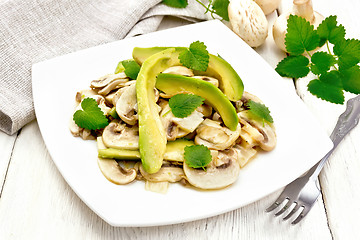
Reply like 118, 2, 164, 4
273, 0, 324, 52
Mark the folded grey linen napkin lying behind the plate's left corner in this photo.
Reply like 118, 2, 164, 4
0, 0, 209, 134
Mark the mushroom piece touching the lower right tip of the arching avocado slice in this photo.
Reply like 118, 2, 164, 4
195, 118, 241, 150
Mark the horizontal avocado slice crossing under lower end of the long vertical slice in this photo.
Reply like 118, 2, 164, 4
98, 139, 195, 162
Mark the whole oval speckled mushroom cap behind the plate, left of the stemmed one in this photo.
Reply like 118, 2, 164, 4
228, 0, 268, 47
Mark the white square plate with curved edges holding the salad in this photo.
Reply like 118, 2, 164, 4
32, 21, 332, 226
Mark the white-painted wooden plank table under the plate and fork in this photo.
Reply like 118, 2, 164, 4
0, 0, 360, 240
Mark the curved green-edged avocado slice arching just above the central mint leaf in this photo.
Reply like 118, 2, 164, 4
156, 73, 239, 131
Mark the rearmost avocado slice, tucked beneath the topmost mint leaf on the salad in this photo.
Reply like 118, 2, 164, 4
133, 47, 244, 101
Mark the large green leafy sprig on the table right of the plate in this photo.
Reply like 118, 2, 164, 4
275, 15, 360, 104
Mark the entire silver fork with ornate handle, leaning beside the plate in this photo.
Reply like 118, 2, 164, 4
266, 95, 360, 224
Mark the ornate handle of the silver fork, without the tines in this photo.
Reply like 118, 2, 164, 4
306, 95, 360, 178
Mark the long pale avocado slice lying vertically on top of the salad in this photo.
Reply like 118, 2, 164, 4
136, 48, 183, 173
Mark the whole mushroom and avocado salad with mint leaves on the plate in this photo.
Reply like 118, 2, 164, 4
70, 41, 276, 192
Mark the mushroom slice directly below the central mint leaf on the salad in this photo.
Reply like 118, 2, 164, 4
160, 103, 204, 141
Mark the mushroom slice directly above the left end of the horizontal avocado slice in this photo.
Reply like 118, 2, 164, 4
102, 120, 139, 150
